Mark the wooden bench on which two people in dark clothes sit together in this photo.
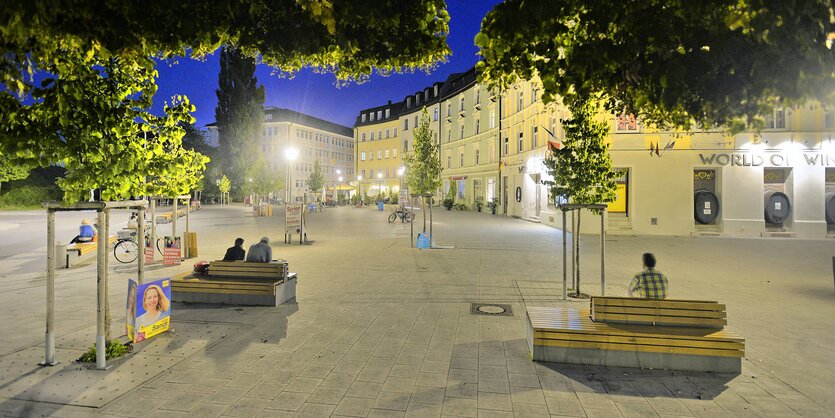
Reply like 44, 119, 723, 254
171, 261, 297, 306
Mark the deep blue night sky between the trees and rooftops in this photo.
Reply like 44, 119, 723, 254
153, 0, 499, 131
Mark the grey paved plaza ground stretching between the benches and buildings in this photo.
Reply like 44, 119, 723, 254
0, 207, 835, 417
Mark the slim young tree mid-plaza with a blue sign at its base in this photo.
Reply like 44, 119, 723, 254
403, 107, 441, 233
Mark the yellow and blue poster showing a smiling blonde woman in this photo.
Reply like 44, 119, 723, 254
126, 278, 171, 343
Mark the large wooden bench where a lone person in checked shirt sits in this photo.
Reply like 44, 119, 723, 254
527, 298, 745, 373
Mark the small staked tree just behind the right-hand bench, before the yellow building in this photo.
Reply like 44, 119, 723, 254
543, 96, 617, 297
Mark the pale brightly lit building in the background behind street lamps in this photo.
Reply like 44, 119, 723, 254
207, 107, 355, 202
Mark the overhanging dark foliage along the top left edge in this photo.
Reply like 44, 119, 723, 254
0, 0, 450, 80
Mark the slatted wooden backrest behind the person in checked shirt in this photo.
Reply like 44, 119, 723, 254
591, 297, 728, 328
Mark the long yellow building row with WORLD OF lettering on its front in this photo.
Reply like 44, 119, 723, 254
354, 70, 835, 238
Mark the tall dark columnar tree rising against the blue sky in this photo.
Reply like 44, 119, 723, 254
215, 48, 264, 198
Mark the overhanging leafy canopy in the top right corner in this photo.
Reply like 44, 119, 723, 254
475, 0, 835, 131
